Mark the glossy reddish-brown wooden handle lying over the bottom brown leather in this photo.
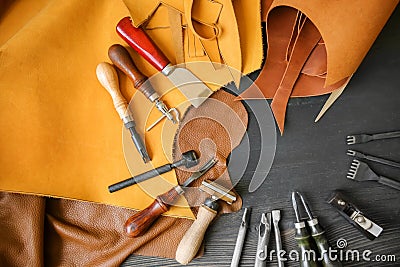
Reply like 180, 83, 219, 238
124, 187, 179, 237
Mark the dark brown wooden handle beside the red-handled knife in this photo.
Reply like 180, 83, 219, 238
108, 44, 158, 101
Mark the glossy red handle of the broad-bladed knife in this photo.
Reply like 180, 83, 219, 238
117, 17, 169, 71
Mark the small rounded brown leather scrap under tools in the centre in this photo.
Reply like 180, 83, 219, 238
174, 90, 248, 216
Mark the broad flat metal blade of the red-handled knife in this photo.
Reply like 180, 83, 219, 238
168, 68, 214, 108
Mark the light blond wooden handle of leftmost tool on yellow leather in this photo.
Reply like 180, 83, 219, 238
96, 62, 128, 119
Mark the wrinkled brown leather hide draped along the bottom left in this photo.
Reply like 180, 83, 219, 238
0, 192, 192, 266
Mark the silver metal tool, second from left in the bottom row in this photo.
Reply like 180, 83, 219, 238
254, 215, 272, 267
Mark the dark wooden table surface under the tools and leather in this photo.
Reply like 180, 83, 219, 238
123, 8, 400, 266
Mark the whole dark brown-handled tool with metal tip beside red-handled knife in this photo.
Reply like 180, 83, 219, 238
108, 44, 179, 130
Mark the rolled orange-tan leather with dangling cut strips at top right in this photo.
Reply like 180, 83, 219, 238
238, 0, 398, 133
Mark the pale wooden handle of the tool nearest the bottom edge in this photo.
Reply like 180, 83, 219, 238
175, 206, 217, 264
